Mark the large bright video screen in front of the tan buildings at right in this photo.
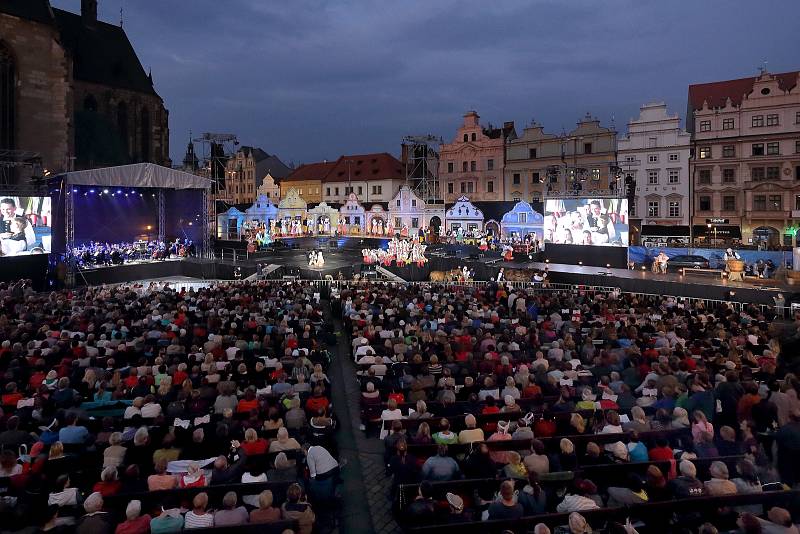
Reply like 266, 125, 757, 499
544, 198, 628, 247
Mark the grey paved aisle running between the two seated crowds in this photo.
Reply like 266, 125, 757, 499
330, 310, 401, 534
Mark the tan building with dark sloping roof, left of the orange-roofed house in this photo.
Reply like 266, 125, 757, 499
220, 146, 291, 204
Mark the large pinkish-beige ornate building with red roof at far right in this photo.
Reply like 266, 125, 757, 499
686, 67, 800, 246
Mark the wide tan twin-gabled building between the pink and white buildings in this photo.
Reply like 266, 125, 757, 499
503, 113, 617, 202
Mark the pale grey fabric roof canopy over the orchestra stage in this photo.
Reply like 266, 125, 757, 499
59, 163, 212, 189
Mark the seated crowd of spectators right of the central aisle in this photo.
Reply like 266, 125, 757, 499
340, 282, 800, 533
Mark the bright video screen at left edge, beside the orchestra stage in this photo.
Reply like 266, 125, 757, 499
0, 197, 52, 258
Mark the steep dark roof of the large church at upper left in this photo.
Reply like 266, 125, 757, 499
52, 7, 156, 95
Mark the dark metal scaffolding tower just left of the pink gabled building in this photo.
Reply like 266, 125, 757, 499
401, 134, 444, 204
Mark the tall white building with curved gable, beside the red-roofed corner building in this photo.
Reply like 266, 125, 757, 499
617, 102, 691, 230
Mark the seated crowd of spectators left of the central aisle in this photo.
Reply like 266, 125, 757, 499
0, 282, 339, 534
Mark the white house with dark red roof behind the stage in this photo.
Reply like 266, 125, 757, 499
322, 152, 405, 204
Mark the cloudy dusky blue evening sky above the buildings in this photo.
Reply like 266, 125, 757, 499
51, 0, 800, 168
